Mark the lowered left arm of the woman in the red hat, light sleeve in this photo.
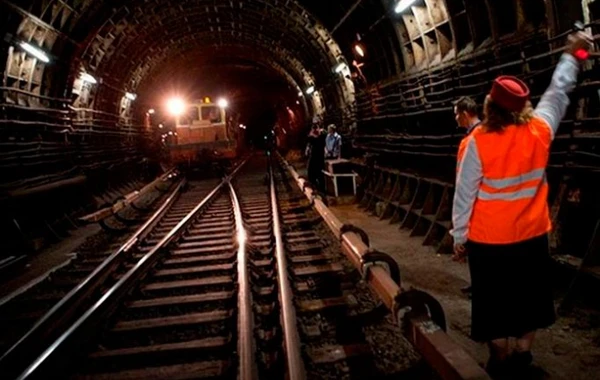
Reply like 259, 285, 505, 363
450, 136, 483, 245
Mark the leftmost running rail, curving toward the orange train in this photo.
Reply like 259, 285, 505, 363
0, 174, 185, 375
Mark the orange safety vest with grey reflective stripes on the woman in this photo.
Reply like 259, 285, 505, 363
458, 117, 552, 244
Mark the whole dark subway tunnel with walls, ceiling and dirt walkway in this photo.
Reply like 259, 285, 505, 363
0, 0, 600, 379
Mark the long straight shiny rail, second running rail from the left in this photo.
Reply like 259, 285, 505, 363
17, 159, 248, 380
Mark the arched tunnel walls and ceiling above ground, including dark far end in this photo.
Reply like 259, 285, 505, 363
0, 0, 600, 342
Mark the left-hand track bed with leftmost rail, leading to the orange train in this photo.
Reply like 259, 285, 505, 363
0, 175, 223, 373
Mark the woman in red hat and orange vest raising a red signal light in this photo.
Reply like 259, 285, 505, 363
451, 32, 591, 375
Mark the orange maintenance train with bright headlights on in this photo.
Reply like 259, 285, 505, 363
164, 98, 241, 166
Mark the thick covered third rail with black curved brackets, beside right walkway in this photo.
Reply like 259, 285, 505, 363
278, 156, 491, 380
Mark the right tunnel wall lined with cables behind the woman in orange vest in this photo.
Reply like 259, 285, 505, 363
354, 0, 600, 180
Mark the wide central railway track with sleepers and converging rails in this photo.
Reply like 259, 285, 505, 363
8, 157, 488, 380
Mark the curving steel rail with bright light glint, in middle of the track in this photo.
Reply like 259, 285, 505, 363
228, 182, 258, 380
